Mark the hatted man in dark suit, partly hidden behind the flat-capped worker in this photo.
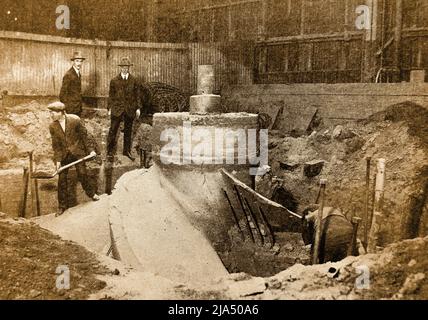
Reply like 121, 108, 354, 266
59, 52, 85, 117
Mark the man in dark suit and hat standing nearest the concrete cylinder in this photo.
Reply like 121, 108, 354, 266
107, 58, 141, 161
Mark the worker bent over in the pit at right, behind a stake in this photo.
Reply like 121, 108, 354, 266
302, 205, 353, 263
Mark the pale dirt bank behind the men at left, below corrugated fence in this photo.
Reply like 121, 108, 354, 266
0, 101, 151, 170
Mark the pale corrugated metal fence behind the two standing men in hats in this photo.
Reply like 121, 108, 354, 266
0, 31, 254, 97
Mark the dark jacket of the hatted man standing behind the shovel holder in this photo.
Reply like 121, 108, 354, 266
59, 67, 82, 113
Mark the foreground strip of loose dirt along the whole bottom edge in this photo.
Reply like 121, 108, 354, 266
0, 210, 428, 300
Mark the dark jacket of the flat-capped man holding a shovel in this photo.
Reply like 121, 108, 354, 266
49, 114, 95, 162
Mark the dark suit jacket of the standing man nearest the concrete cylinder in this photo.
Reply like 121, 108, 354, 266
108, 74, 141, 118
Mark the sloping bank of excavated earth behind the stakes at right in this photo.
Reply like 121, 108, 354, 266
266, 103, 428, 245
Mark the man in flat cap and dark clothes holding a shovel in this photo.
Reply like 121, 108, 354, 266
48, 102, 99, 215
